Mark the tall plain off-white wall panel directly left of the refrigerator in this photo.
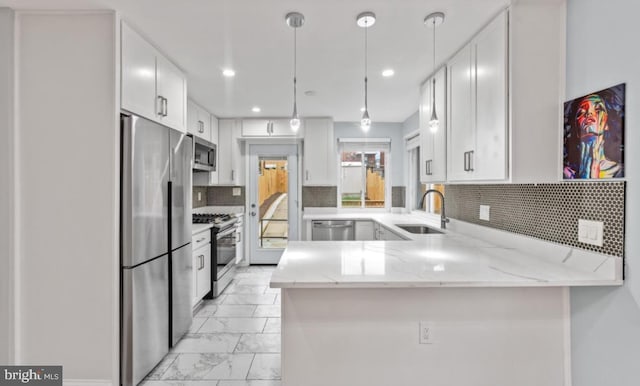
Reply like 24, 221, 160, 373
15, 12, 119, 383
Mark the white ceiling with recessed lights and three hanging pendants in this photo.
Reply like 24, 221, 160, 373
0, 0, 508, 122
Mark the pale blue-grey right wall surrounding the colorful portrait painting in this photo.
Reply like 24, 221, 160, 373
566, 0, 640, 386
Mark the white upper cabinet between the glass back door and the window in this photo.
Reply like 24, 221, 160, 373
302, 118, 338, 186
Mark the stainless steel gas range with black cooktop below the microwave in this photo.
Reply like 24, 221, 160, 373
193, 213, 240, 299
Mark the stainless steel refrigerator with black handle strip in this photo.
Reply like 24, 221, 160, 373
120, 114, 193, 385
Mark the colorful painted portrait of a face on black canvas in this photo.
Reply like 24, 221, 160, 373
563, 83, 625, 179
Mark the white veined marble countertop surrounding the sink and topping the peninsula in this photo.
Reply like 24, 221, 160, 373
270, 213, 622, 288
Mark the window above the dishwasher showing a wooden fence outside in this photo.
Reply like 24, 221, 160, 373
339, 140, 391, 208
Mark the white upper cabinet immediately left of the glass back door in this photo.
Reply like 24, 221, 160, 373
217, 119, 244, 185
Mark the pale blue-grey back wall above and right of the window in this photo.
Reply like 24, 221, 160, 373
333, 122, 404, 186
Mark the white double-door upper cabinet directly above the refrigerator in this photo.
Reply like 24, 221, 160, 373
121, 22, 187, 132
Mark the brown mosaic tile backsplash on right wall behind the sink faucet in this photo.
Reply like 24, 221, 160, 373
445, 182, 625, 256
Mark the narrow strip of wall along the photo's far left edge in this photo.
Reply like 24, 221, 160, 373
0, 8, 15, 364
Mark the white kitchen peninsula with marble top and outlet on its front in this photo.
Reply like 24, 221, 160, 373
271, 214, 622, 386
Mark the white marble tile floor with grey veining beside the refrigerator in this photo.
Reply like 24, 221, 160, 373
140, 266, 280, 386
